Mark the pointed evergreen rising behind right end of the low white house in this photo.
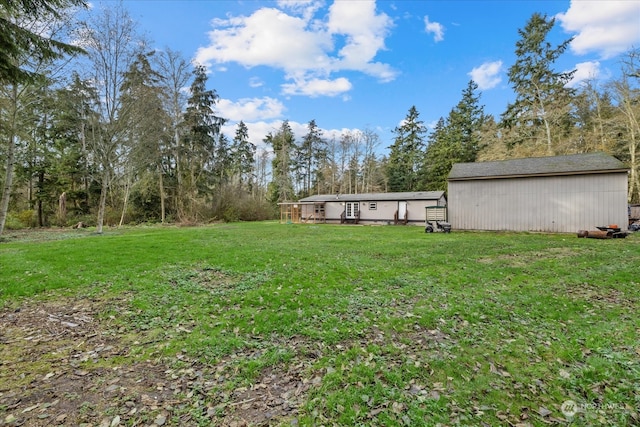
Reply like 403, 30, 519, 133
387, 106, 427, 191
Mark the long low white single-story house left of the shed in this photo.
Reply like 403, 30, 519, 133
280, 191, 447, 226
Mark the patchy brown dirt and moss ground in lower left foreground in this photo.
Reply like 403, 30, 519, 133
0, 298, 313, 427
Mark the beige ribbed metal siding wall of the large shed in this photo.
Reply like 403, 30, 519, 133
448, 173, 627, 232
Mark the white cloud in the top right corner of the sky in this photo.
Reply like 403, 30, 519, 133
556, 0, 640, 59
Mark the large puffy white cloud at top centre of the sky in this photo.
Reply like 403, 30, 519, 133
196, 0, 397, 96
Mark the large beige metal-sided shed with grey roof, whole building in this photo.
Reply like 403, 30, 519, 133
447, 153, 628, 232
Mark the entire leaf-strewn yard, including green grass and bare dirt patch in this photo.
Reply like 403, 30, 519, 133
0, 226, 640, 426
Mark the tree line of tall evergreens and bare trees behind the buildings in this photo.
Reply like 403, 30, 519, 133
0, 0, 640, 234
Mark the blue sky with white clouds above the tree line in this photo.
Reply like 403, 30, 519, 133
93, 0, 640, 154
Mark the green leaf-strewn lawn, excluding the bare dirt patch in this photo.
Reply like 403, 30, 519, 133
0, 222, 640, 426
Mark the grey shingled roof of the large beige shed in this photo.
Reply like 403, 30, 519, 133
448, 153, 627, 181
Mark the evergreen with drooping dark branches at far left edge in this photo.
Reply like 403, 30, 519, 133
0, 0, 84, 236
